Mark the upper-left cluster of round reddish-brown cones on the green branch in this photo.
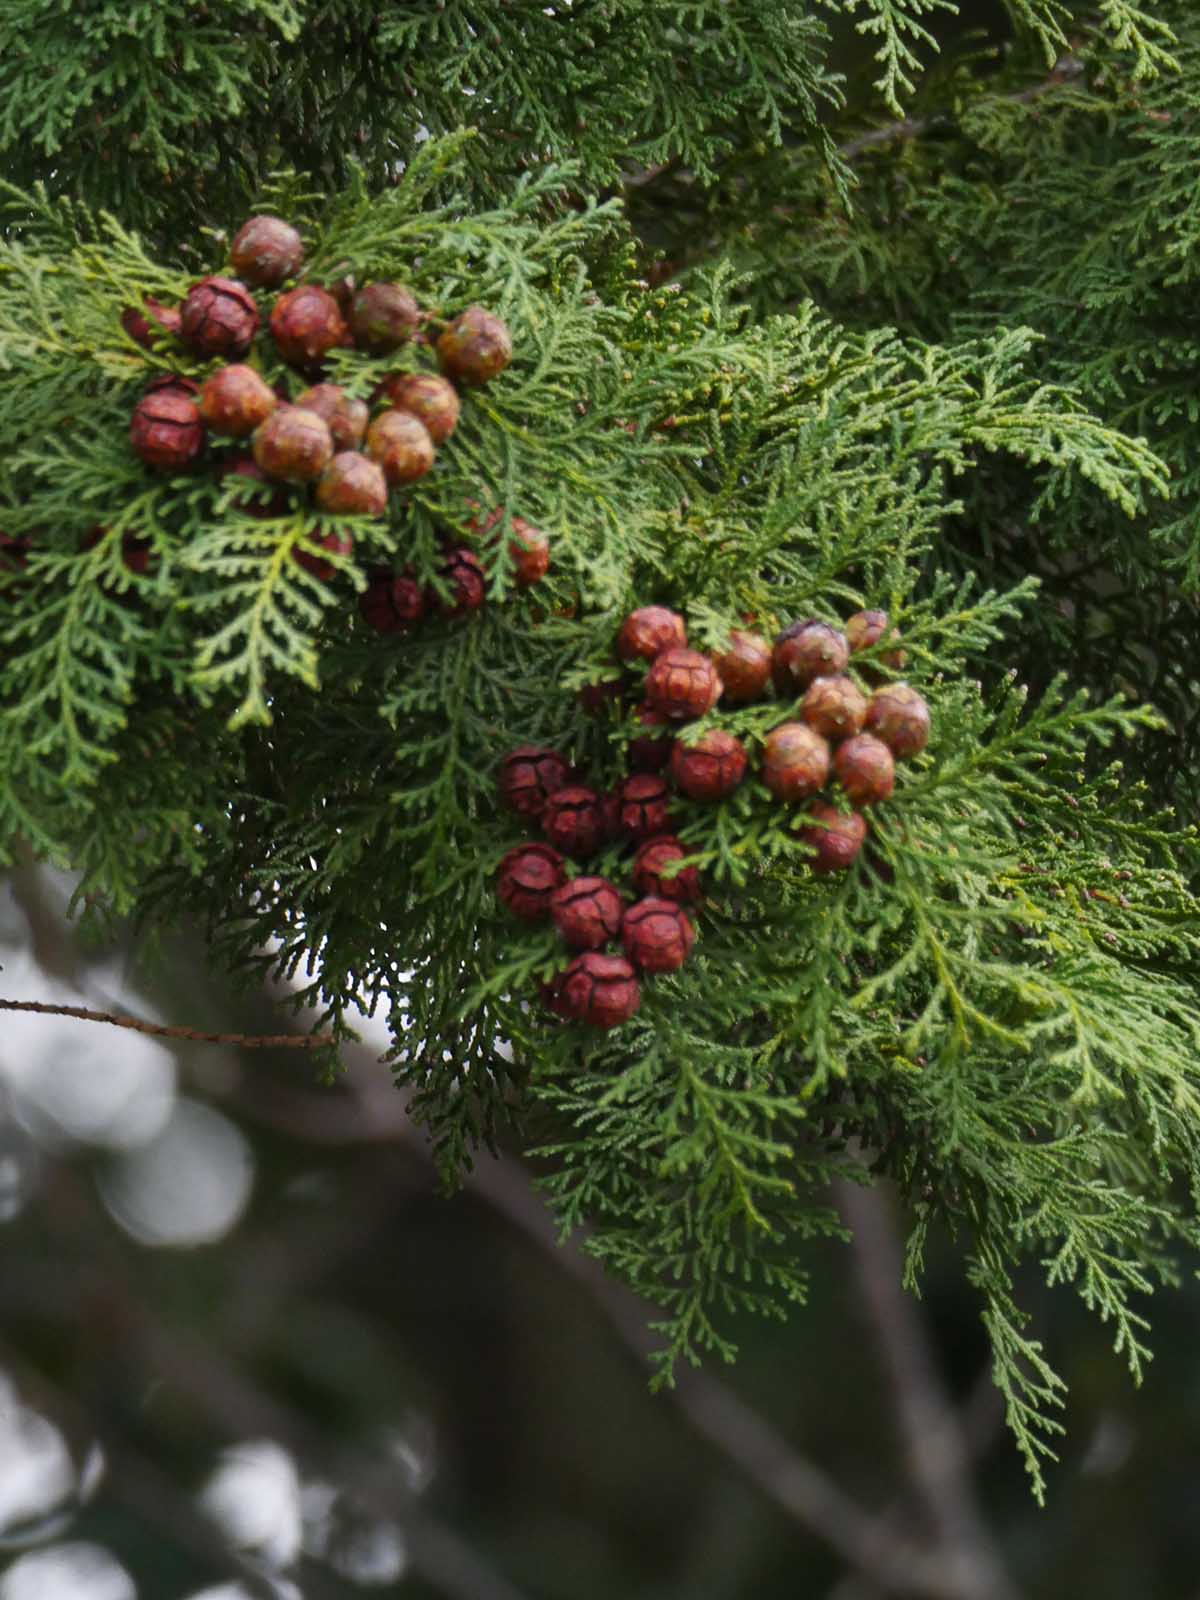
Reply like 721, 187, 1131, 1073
122, 216, 518, 588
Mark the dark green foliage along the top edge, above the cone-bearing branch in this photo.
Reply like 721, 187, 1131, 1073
0, 0, 1168, 241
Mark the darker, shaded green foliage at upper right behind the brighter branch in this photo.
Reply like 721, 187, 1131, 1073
691, 5, 1200, 811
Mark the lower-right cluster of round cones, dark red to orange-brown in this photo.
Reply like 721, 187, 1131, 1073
496, 605, 930, 1027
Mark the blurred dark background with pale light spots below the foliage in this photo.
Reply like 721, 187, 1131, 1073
0, 867, 1200, 1600
